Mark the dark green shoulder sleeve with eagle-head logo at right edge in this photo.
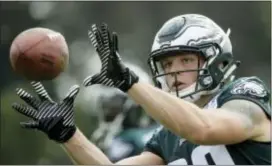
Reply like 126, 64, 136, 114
217, 77, 271, 118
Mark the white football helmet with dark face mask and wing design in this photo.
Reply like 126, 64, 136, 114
148, 14, 240, 102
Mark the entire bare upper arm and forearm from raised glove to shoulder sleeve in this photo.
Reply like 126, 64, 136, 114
128, 83, 270, 144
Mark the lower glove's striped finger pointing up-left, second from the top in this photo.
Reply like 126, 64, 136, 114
16, 88, 39, 109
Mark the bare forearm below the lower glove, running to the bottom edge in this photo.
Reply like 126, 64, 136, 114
63, 129, 112, 165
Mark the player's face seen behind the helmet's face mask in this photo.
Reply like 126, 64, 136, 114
160, 53, 204, 91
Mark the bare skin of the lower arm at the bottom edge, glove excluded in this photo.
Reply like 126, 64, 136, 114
63, 129, 164, 165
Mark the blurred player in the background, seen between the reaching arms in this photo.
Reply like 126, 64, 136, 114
90, 87, 158, 162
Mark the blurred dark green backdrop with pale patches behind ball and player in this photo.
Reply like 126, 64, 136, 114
0, 1, 271, 164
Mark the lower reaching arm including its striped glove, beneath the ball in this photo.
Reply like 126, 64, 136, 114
13, 82, 162, 165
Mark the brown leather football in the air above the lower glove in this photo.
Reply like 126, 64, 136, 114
10, 27, 69, 81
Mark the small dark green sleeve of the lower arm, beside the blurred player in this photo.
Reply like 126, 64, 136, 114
144, 127, 165, 158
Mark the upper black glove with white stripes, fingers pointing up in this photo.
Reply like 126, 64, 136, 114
83, 24, 139, 92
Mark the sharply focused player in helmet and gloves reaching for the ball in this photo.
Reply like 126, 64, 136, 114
13, 14, 271, 165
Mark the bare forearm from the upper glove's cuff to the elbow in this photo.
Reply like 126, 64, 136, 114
128, 83, 209, 140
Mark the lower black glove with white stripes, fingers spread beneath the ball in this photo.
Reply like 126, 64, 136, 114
12, 82, 79, 143
